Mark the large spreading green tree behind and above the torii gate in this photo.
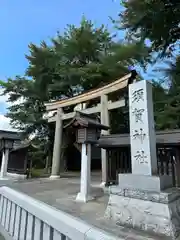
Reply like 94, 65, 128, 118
2, 19, 150, 138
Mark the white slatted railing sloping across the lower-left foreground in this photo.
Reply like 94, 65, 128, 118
0, 187, 118, 240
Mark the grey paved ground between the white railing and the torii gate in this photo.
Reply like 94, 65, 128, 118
0, 176, 169, 240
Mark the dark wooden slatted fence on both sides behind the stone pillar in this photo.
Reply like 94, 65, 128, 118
107, 146, 180, 186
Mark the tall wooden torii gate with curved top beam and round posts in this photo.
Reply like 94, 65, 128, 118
45, 70, 137, 185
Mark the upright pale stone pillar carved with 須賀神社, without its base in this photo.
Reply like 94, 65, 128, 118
129, 80, 157, 175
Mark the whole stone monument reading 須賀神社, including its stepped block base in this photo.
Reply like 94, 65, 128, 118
105, 80, 180, 239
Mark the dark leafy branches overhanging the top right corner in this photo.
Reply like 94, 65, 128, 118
119, 0, 180, 54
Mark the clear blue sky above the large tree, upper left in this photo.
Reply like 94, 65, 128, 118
0, 0, 120, 79
